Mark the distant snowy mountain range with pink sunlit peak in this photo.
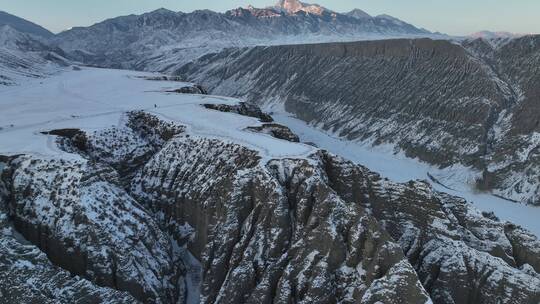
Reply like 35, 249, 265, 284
50, 0, 434, 71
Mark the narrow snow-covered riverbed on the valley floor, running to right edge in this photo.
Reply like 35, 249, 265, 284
272, 111, 540, 237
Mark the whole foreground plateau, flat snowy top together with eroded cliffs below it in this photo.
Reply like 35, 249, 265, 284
0, 67, 540, 304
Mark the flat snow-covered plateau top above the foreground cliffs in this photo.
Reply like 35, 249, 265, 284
0, 68, 314, 160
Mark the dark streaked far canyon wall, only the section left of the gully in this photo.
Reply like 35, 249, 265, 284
178, 40, 505, 165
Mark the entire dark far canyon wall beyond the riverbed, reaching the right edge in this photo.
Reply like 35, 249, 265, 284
177, 36, 540, 204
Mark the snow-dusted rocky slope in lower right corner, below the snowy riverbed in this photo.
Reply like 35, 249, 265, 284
318, 155, 540, 303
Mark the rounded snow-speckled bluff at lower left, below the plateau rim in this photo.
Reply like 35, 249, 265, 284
2, 157, 181, 302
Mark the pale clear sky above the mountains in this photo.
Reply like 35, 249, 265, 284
0, 0, 540, 35
